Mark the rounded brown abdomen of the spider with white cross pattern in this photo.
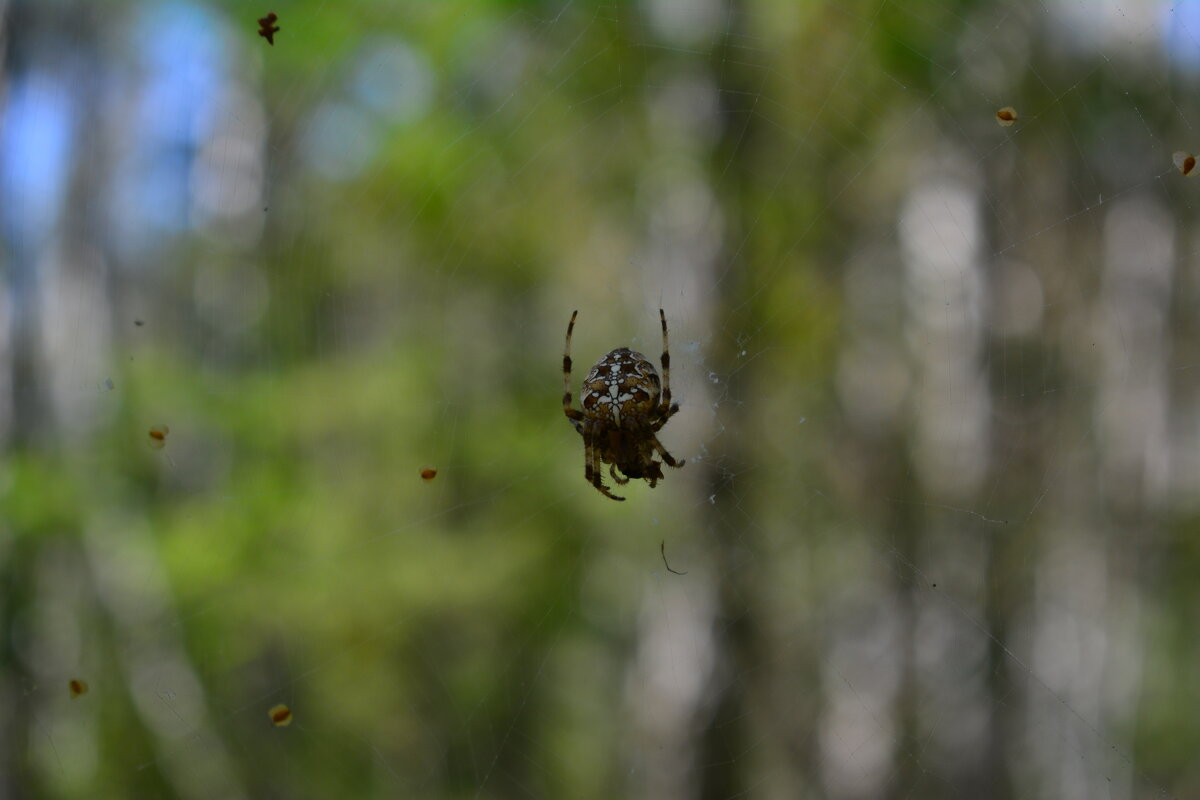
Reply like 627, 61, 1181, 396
580, 348, 661, 428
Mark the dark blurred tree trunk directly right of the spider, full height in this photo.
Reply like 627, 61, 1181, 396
697, 2, 822, 800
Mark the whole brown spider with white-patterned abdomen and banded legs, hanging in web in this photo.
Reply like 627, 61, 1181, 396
563, 308, 684, 500
